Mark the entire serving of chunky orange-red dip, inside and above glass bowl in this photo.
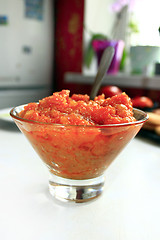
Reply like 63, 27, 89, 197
17, 90, 140, 180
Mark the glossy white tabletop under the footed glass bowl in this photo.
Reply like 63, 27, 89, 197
0, 110, 160, 240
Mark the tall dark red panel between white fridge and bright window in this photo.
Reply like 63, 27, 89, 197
54, 0, 84, 91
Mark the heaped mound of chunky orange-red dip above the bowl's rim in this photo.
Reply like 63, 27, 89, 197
20, 90, 135, 125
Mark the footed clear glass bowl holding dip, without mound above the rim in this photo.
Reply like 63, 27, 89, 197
10, 105, 148, 202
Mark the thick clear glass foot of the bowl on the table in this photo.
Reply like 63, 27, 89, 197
49, 174, 104, 203
